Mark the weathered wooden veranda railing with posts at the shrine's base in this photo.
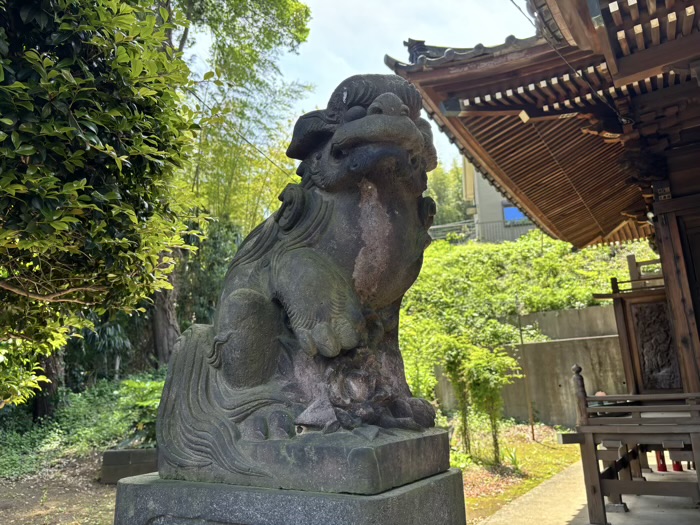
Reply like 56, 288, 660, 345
559, 365, 700, 525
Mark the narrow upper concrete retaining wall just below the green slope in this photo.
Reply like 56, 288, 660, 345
511, 306, 617, 339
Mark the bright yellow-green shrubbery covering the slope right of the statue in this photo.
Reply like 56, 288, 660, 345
399, 231, 654, 463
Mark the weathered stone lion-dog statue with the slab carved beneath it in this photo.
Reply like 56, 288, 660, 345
158, 75, 447, 493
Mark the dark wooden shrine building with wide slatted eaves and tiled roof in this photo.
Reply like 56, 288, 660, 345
385, 0, 700, 523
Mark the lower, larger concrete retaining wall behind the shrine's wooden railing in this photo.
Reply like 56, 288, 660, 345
503, 335, 627, 427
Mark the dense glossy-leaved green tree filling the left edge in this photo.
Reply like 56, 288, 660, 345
0, 0, 193, 403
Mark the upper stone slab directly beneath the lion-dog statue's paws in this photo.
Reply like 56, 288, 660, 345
160, 426, 450, 494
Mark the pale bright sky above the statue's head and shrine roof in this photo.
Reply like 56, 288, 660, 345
279, 0, 535, 164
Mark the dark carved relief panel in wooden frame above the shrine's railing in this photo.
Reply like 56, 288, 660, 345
630, 302, 683, 390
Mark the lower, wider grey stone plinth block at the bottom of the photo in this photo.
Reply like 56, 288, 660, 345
114, 469, 466, 525
